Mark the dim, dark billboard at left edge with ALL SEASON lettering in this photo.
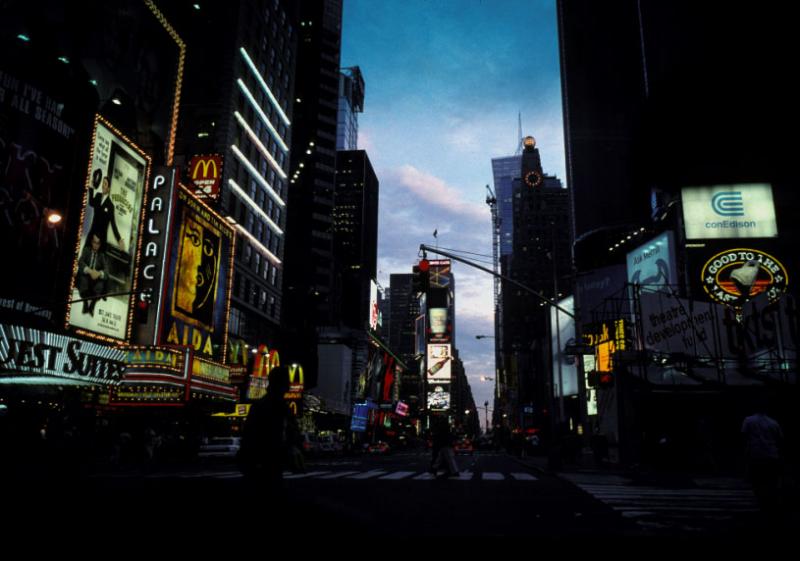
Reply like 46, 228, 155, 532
0, 60, 91, 321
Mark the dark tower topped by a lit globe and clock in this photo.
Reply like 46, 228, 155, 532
497, 137, 572, 426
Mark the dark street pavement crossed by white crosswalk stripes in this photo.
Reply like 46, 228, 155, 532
3, 451, 785, 543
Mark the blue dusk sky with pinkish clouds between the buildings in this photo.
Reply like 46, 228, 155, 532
341, 0, 566, 427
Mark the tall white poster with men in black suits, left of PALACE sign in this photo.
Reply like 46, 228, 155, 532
66, 115, 150, 340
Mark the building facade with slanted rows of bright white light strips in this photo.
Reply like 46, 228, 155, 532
174, 0, 299, 358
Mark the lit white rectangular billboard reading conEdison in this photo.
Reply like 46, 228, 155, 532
681, 183, 778, 240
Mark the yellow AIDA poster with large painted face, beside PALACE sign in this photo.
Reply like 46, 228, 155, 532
160, 185, 236, 362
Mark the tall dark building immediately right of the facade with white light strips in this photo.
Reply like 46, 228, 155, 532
284, 0, 342, 384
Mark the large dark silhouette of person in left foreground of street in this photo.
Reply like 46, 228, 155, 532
238, 366, 299, 506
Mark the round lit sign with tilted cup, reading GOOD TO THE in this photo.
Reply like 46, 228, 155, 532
701, 248, 789, 309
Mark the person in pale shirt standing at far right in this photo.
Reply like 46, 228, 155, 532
742, 399, 783, 519
